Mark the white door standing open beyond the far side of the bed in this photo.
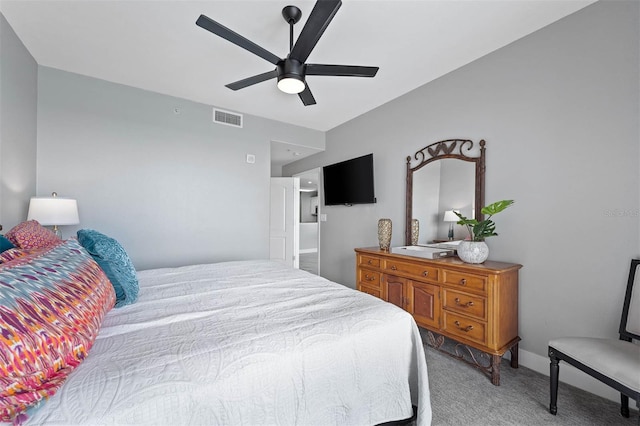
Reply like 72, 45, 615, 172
269, 177, 300, 268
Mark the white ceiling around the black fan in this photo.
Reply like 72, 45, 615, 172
0, 0, 594, 135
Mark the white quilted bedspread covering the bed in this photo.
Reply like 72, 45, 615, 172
29, 261, 431, 425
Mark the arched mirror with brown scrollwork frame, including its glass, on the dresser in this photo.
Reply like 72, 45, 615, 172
405, 139, 485, 245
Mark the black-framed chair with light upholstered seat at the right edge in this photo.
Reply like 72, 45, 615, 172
549, 259, 640, 424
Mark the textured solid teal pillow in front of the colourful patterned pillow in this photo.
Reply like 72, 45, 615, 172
77, 229, 138, 308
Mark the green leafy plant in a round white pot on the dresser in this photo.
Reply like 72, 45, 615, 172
454, 200, 514, 263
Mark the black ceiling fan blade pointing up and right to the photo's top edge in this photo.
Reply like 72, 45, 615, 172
289, 0, 342, 63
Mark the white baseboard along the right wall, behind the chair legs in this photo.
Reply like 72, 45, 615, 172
518, 349, 620, 406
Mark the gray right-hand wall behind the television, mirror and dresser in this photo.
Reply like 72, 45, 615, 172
283, 1, 640, 368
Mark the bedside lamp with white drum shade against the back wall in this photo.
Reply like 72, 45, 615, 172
27, 192, 80, 238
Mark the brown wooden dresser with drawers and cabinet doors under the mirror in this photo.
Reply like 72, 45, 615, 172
355, 247, 522, 385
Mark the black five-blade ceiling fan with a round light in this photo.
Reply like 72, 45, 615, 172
196, 0, 378, 106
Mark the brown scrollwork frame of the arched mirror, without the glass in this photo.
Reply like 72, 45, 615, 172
404, 139, 486, 245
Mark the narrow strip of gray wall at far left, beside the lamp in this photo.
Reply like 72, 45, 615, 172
0, 14, 38, 232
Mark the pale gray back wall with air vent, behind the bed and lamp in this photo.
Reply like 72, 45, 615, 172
38, 67, 325, 269
